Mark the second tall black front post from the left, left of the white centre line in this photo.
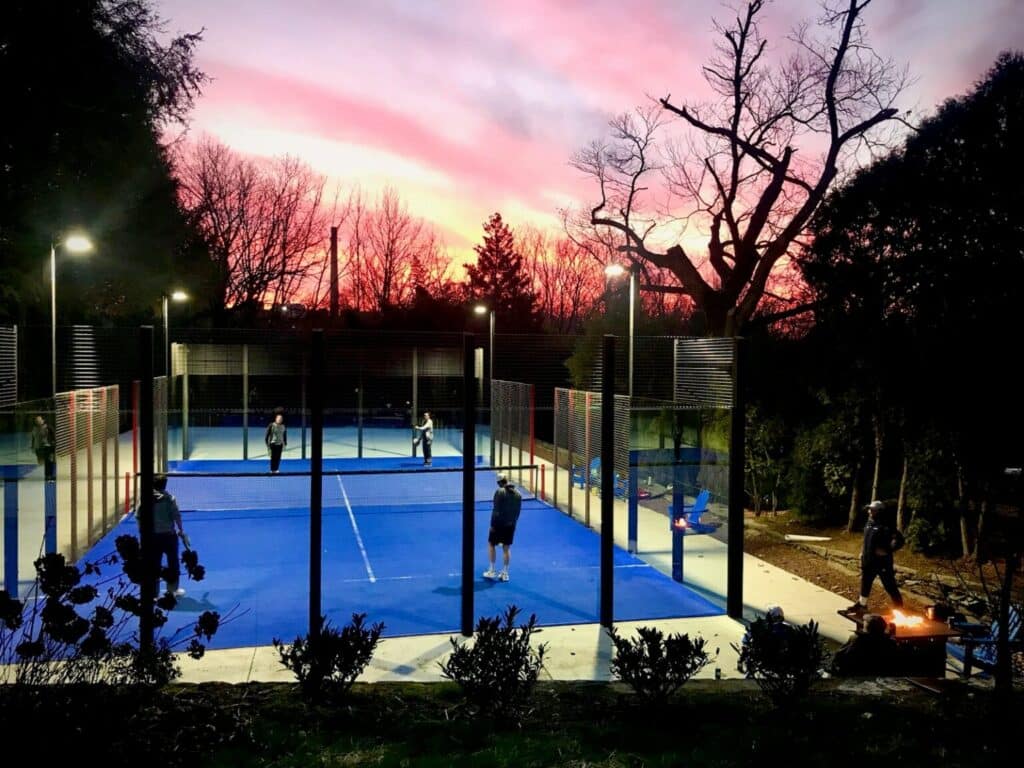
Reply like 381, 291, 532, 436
308, 329, 326, 641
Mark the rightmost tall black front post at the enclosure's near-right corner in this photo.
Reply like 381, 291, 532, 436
725, 337, 746, 620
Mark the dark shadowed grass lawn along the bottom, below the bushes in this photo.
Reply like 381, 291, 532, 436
0, 680, 1024, 768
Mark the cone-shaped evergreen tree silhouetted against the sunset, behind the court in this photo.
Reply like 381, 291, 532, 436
466, 213, 540, 331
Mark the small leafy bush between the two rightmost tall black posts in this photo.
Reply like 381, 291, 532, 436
608, 627, 718, 703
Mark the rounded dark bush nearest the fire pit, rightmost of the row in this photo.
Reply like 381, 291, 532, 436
732, 618, 824, 707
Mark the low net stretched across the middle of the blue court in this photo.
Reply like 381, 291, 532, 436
157, 465, 543, 515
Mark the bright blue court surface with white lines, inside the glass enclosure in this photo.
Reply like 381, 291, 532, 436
72, 457, 724, 648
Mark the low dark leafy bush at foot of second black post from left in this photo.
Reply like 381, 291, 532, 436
273, 613, 384, 701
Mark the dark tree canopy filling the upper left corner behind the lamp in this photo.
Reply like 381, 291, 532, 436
0, 0, 206, 323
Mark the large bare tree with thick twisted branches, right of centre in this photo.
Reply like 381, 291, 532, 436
573, 0, 905, 335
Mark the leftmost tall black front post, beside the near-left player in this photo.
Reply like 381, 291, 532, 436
137, 326, 160, 651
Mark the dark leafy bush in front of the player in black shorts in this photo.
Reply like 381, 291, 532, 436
439, 605, 547, 719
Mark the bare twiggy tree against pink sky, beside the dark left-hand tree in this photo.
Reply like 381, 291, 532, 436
175, 138, 330, 308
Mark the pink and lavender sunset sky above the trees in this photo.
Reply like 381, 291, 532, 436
159, 0, 1024, 260
